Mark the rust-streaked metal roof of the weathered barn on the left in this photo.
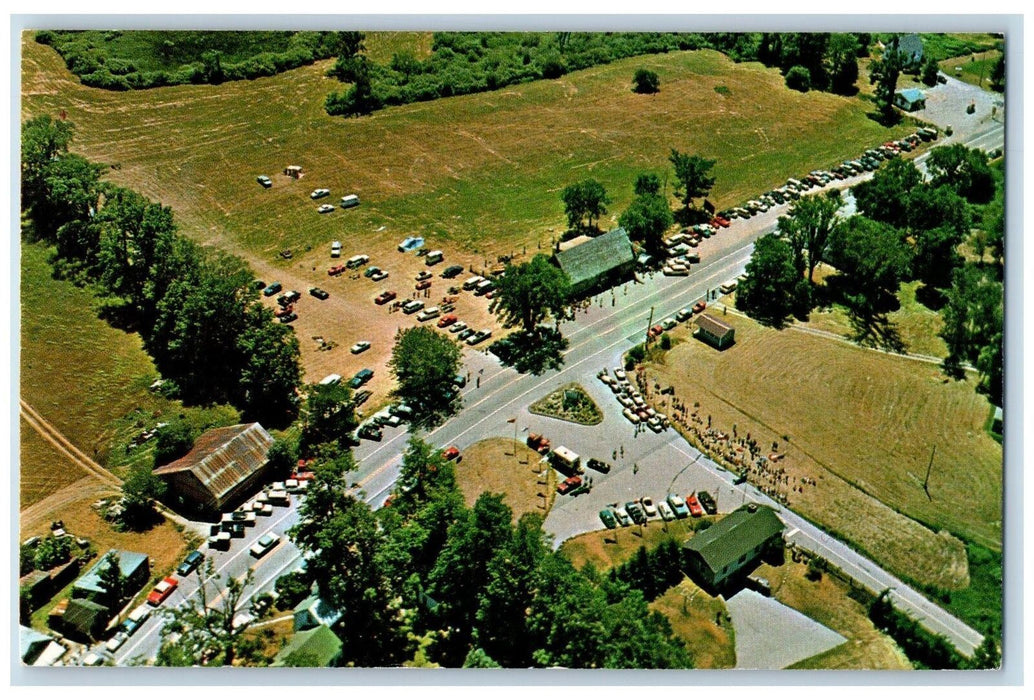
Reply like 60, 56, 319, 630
154, 423, 273, 498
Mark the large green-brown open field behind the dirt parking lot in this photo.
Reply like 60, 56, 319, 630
23, 37, 907, 270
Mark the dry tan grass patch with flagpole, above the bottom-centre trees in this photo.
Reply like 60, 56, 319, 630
456, 437, 556, 521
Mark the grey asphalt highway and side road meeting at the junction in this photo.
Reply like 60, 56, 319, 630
95, 78, 1004, 665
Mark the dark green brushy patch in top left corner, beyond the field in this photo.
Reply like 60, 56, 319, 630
36, 31, 338, 90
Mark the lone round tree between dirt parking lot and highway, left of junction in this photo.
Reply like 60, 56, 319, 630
388, 326, 460, 425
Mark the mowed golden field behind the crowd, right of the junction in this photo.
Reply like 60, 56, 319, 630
648, 314, 1002, 588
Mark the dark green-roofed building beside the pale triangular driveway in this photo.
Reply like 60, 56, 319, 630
683, 504, 784, 588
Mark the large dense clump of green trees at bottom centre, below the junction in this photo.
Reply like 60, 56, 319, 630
292, 438, 691, 668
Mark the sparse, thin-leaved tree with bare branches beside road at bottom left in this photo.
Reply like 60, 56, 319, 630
155, 559, 254, 666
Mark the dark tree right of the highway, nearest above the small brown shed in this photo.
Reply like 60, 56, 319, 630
736, 234, 800, 328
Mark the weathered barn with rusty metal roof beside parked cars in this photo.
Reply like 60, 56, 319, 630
154, 423, 273, 513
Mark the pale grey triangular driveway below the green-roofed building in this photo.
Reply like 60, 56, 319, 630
725, 590, 847, 671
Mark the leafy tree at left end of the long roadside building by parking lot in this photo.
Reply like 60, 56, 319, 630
494, 253, 571, 335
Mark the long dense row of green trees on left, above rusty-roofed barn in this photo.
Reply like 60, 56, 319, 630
22, 116, 301, 425
